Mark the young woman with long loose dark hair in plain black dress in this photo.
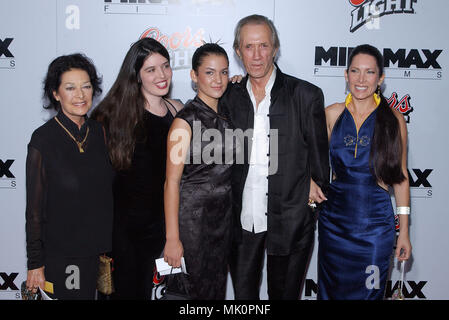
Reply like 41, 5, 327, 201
92, 38, 182, 299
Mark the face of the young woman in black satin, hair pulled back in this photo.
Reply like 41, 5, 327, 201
190, 54, 229, 105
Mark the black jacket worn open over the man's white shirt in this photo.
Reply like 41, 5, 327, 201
220, 68, 329, 255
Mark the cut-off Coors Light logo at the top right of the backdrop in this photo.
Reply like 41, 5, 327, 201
349, 0, 418, 32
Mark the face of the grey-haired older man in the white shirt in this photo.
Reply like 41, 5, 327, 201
236, 24, 277, 79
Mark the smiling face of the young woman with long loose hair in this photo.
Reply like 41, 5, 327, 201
139, 53, 173, 97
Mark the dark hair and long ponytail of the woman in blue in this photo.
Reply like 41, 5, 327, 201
348, 44, 405, 185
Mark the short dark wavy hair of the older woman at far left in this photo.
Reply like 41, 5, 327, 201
44, 53, 102, 111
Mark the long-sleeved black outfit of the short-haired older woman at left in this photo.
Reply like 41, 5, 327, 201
26, 112, 113, 299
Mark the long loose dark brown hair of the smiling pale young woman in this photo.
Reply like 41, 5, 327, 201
92, 38, 170, 170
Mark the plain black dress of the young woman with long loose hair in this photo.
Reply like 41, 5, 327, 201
112, 100, 176, 300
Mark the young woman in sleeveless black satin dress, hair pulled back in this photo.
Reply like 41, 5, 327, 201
164, 43, 234, 300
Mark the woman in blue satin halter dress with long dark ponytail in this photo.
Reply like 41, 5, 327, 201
318, 45, 411, 300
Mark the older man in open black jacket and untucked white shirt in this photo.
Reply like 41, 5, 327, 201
220, 15, 329, 300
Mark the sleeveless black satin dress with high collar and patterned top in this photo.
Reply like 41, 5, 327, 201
172, 97, 234, 300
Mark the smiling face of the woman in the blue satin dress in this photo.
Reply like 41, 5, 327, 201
345, 53, 385, 100
